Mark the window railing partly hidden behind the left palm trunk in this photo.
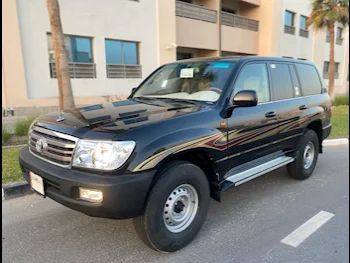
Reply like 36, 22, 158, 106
49, 62, 96, 79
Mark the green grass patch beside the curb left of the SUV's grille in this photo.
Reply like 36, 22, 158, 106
2, 147, 24, 184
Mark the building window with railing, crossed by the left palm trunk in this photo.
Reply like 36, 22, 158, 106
47, 33, 96, 78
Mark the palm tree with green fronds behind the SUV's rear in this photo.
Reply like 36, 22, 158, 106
307, 0, 349, 99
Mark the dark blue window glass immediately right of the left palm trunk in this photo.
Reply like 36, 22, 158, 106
70, 37, 92, 63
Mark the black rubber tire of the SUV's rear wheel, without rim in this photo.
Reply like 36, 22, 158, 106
287, 130, 320, 180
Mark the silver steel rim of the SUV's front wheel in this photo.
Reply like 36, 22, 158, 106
163, 184, 198, 233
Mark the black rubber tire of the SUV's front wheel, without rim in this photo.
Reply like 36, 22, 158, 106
134, 161, 210, 253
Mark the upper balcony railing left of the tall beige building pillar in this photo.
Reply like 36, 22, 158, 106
176, 1, 217, 23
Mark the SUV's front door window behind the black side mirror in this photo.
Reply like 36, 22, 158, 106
234, 64, 270, 103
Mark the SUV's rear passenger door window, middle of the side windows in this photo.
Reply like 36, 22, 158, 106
271, 63, 294, 100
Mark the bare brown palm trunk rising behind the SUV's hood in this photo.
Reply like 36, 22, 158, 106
46, 0, 75, 110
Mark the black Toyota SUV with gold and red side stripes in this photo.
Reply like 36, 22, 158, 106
19, 57, 331, 252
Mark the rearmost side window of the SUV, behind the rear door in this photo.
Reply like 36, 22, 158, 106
296, 64, 322, 96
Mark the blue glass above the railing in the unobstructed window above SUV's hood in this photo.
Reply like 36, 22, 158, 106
105, 40, 139, 65
